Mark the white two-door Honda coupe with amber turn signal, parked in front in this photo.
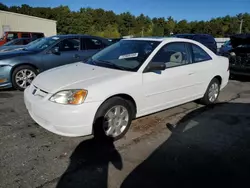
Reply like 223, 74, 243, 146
24, 38, 229, 140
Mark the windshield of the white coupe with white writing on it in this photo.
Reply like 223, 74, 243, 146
85, 40, 160, 72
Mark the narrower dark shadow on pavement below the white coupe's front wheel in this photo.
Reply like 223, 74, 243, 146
57, 138, 122, 188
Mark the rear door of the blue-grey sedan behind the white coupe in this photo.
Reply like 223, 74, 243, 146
78, 37, 104, 61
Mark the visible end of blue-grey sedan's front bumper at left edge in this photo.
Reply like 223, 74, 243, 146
0, 65, 12, 89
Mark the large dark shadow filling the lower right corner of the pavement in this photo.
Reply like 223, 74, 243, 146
121, 103, 250, 188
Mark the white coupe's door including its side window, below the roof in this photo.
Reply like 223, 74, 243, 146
141, 42, 194, 114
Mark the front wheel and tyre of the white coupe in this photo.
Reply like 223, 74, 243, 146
93, 97, 134, 140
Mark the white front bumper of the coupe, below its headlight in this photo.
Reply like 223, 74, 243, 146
24, 85, 101, 137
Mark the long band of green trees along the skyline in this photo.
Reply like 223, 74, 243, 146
0, 3, 250, 38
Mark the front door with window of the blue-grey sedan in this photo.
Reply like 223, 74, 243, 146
42, 37, 80, 70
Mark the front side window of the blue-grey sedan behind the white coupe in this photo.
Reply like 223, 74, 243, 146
57, 38, 80, 52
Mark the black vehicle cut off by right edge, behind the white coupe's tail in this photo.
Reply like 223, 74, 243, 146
229, 34, 250, 76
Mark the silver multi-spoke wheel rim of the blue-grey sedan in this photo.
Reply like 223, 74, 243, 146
15, 69, 36, 89
